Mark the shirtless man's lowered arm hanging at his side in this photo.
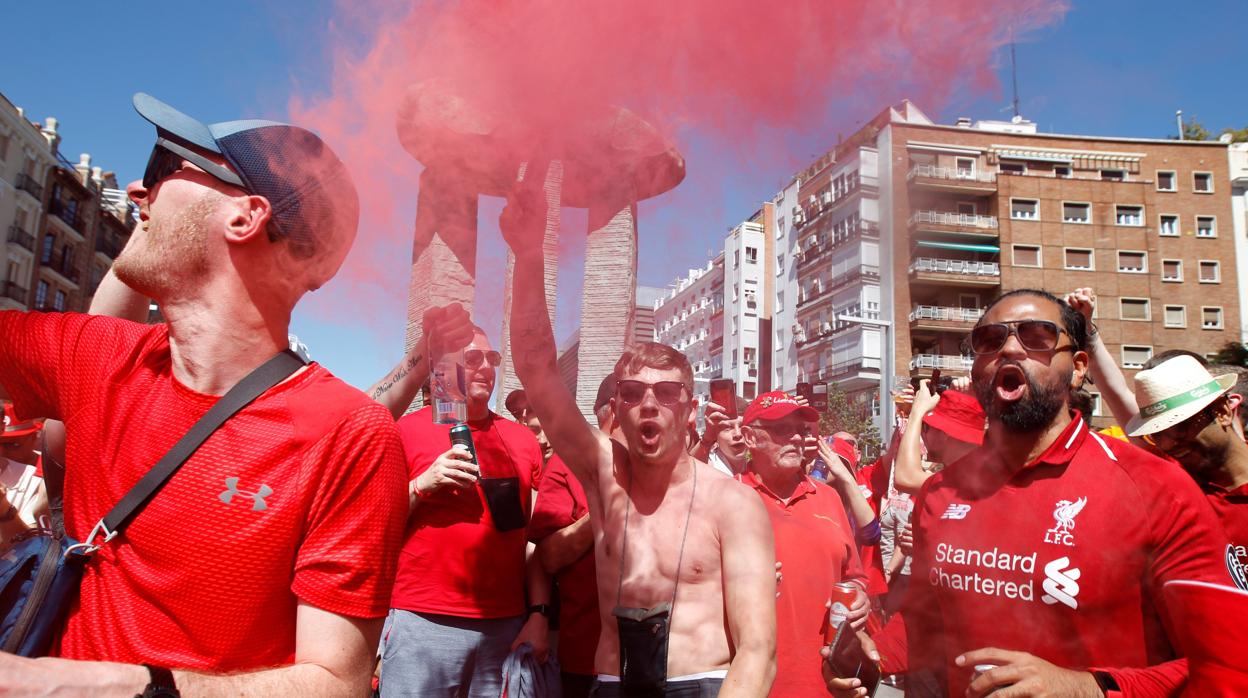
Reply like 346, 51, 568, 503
719, 483, 773, 698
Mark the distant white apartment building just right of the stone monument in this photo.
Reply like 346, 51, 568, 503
654, 252, 740, 405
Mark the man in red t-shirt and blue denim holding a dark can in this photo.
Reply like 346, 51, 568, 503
381, 328, 549, 698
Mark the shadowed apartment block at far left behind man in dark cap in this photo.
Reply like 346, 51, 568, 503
0, 90, 135, 311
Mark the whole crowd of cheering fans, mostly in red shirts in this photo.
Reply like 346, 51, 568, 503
0, 95, 1248, 698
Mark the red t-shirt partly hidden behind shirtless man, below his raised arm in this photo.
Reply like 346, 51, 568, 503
529, 456, 602, 674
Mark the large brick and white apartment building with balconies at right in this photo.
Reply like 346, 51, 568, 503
776, 102, 1242, 432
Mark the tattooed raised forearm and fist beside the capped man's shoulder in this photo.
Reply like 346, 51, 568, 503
368, 303, 473, 420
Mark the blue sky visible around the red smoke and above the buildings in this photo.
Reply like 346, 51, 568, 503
0, 0, 1248, 387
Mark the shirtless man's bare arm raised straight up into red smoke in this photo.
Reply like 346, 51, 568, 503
498, 162, 610, 489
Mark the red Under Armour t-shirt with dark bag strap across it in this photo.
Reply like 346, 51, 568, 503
0, 312, 407, 672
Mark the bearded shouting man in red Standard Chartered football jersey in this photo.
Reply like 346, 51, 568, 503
904, 290, 1226, 697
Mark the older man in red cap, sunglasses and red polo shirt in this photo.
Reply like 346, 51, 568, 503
740, 391, 869, 697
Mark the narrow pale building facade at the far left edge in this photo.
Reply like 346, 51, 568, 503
0, 95, 56, 310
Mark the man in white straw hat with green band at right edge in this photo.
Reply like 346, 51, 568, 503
1127, 356, 1248, 591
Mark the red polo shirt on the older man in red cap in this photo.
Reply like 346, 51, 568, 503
738, 472, 866, 697
